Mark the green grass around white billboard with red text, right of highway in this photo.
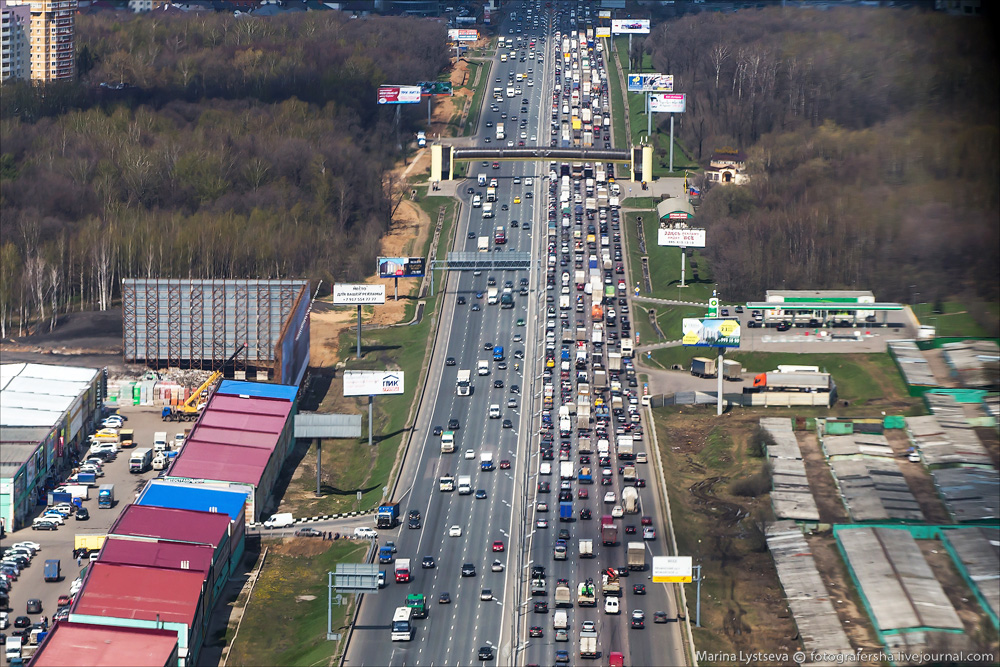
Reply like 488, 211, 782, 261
625, 209, 715, 302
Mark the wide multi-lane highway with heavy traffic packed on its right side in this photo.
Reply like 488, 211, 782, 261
346, 3, 682, 665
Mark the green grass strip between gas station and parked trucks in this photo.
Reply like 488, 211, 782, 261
653, 346, 923, 414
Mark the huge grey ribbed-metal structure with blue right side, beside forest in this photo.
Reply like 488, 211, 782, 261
122, 278, 310, 385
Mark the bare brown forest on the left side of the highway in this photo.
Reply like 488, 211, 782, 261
0, 11, 448, 337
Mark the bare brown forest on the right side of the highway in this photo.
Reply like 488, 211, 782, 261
630, 6, 1000, 302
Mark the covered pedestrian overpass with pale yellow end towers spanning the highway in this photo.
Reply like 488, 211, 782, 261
430, 144, 653, 183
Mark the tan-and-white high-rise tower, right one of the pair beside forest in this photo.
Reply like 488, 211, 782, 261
29, 0, 77, 83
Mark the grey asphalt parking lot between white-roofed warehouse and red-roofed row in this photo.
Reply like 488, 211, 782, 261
0, 406, 182, 637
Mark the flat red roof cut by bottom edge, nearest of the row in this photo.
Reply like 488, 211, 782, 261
31, 621, 178, 667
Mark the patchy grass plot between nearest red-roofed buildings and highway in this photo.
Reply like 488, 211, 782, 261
229, 538, 368, 666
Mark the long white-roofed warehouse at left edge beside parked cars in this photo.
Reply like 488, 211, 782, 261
0, 364, 107, 530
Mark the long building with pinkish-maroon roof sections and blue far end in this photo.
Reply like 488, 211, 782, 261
166, 380, 298, 522
